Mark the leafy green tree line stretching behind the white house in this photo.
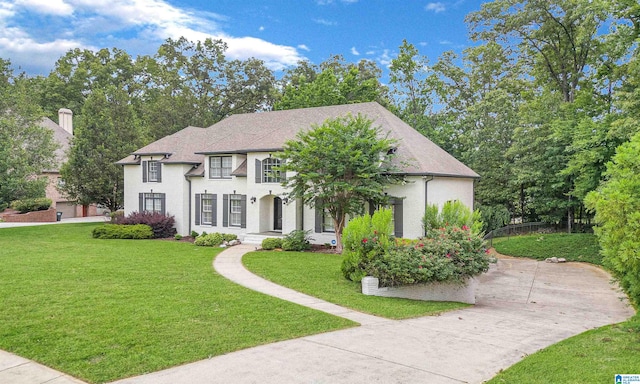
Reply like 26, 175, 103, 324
0, 0, 640, 236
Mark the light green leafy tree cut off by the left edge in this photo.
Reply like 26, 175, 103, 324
0, 59, 57, 210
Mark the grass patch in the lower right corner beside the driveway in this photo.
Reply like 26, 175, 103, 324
487, 315, 640, 384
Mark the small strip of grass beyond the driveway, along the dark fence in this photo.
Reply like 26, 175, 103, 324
493, 233, 602, 265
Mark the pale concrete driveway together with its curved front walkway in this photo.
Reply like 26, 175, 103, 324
112, 245, 633, 384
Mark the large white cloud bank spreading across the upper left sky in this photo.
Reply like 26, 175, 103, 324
0, 0, 308, 71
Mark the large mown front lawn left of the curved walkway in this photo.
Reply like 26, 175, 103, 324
0, 224, 355, 383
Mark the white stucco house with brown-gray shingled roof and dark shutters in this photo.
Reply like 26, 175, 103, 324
118, 102, 479, 244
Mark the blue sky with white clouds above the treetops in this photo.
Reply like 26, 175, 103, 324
0, 0, 482, 75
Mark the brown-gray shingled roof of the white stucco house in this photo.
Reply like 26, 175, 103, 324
119, 102, 479, 178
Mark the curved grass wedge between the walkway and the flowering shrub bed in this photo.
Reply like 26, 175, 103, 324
242, 251, 469, 319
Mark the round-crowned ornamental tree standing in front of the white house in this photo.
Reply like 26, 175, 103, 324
281, 114, 402, 252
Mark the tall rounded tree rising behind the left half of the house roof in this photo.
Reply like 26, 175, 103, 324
140, 37, 275, 138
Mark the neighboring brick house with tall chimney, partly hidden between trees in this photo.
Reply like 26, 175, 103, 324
40, 108, 97, 218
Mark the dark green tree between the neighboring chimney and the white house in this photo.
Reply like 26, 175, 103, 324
60, 86, 146, 211
